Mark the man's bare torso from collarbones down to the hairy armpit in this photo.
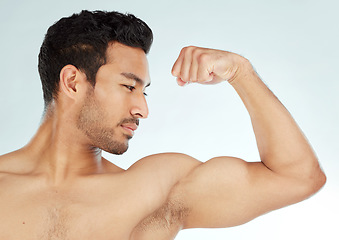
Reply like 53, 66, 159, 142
0, 151, 199, 240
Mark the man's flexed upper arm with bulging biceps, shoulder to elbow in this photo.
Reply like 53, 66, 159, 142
170, 157, 316, 228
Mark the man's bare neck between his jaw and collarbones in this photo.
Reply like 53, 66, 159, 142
24, 114, 103, 185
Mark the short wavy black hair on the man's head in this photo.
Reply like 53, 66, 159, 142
39, 11, 153, 107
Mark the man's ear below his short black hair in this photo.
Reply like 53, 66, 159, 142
60, 65, 86, 99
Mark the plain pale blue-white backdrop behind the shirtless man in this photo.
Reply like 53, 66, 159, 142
0, 0, 339, 240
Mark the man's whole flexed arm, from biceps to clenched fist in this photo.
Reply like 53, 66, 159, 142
171, 47, 326, 228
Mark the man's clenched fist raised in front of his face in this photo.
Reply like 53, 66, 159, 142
172, 46, 248, 86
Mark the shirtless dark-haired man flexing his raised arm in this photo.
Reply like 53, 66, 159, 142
0, 11, 326, 240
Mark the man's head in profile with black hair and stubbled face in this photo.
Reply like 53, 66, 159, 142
39, 11, 152, 154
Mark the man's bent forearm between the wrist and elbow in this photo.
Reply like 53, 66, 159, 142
230, 61, 322, 183
